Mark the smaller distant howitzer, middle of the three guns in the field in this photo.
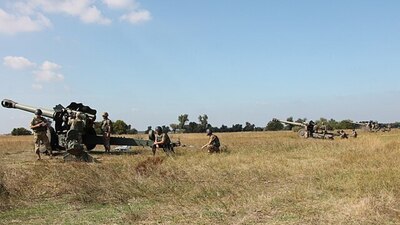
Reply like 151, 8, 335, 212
278, 120, 335, 140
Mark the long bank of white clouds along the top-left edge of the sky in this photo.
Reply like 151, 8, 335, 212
0, 0, 151, 34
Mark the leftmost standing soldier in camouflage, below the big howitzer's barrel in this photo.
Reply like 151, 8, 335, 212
30, 109, 53, 160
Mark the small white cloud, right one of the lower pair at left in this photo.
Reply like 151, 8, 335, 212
33, 61, 64, 82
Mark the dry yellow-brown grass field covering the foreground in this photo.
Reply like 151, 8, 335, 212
0, 130, 400, 224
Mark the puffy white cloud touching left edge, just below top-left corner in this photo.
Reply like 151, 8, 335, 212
0, 9, 51, 34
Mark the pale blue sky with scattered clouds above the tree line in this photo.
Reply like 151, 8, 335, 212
0, 0, 400, 133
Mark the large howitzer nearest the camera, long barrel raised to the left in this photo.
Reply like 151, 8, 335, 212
1, 99, 154, 159
